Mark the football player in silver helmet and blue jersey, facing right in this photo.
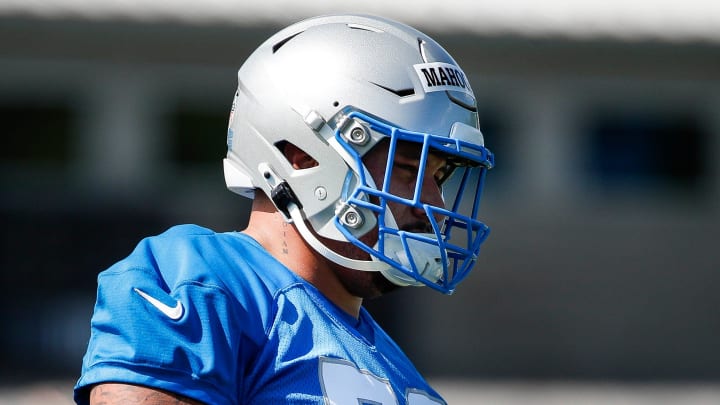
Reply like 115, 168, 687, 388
75, 15, 493, 405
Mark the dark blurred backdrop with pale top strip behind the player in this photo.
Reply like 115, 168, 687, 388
0, 0, 720, 404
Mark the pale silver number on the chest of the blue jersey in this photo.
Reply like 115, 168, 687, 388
320, 357, 443, 405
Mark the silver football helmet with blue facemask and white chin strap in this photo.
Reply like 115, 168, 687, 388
224, 15, 494, 293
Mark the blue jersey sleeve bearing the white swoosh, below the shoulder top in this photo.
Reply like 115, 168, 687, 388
75, 265, 255, 404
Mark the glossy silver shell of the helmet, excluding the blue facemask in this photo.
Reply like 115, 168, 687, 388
226, 15, 478, 230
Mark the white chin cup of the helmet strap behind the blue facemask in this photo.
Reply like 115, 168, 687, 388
373, 233, 443, 286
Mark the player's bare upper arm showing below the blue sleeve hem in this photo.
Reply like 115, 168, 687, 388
90, 383, 202, 405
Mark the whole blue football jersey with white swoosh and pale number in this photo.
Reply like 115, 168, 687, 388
75, 225, 444, 405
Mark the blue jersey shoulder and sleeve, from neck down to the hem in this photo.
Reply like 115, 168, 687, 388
75, 225, 295, 403
